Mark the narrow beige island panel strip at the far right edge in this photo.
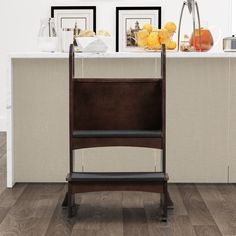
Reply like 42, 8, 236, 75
229, 59, 236, 183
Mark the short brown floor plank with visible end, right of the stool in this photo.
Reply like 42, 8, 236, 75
178, 184, 215, 225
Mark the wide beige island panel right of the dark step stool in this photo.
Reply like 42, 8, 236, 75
167, 59, 228, 182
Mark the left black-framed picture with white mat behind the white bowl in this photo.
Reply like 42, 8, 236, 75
51, 6, 96, 34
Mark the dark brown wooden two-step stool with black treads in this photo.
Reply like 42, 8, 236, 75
64, 45, 172, 221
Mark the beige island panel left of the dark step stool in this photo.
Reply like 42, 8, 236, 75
13, 60, 69, 182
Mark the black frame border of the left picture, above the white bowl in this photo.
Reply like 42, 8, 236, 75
51, 6, 97, 32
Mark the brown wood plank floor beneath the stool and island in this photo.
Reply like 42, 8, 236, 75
0, 133, 236, 236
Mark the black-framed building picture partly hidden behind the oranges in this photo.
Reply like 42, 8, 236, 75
116, 7, 161, 52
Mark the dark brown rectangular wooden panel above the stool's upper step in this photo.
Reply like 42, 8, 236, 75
74, 79, 162, 130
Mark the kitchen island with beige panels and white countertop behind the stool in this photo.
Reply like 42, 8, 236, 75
7, 52, 236, 187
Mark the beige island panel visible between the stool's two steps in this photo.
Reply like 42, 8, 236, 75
82, 147, 159, 172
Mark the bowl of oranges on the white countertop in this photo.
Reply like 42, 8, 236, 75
137, 22, 177, 51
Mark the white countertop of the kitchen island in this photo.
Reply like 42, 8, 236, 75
9, 51, 236, 59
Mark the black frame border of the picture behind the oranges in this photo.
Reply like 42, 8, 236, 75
116, 6, 162, 52
